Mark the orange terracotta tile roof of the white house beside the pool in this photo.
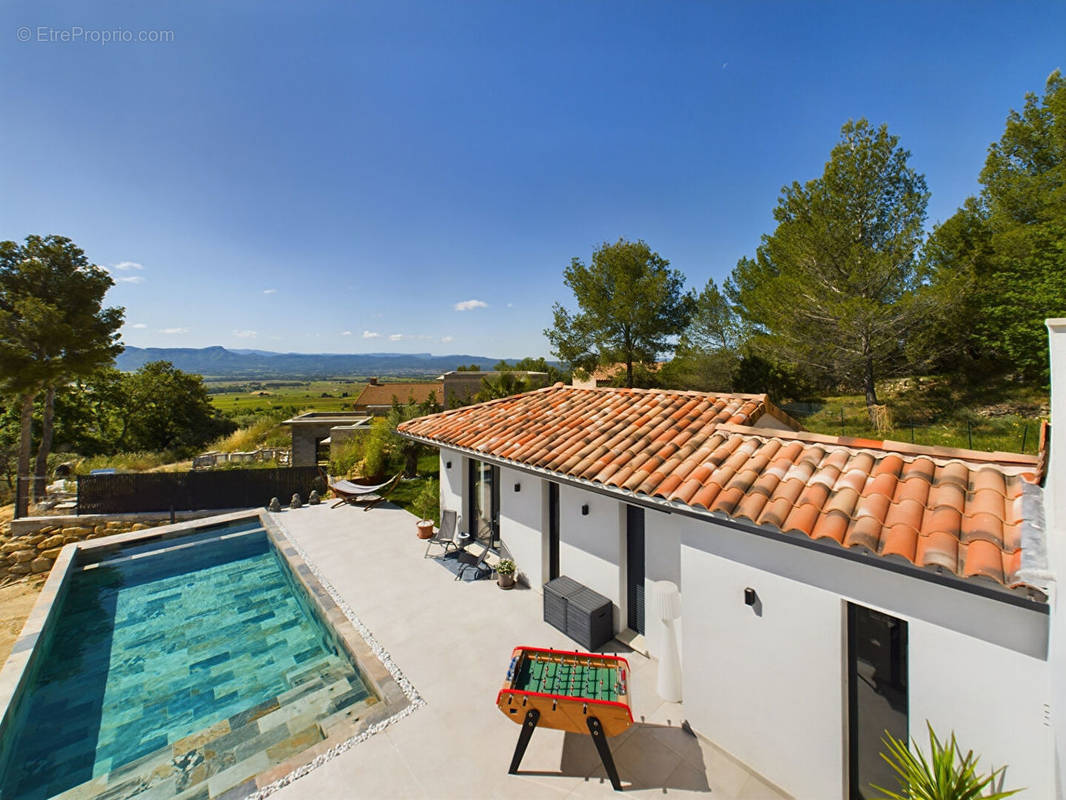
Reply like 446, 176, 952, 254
400, 384, 1039, 597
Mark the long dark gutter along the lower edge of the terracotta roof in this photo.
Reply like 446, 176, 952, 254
397, 430, 1050, 614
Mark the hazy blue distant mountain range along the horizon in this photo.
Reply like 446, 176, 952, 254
115, 347, 500, 378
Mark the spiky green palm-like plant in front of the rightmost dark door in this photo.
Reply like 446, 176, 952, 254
873, 722, 1020, 800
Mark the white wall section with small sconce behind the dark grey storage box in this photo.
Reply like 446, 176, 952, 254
559, 485, 625, 631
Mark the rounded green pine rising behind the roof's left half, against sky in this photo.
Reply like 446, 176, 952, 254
545, 239, 694, 387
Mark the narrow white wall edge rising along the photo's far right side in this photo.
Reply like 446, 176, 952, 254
1044, 318, 1066, 798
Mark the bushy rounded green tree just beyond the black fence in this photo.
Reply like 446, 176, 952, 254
119, 362, 237, 452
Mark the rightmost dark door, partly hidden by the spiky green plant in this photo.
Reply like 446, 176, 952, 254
847, 604, 908, 800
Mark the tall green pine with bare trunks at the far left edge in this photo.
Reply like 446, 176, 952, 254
0, 236, 124, 515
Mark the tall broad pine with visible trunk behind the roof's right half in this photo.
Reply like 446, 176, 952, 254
726, 119, 938, 405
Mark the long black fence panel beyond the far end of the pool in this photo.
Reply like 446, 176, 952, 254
78, 466, 324, 514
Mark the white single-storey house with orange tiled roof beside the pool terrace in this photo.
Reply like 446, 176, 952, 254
401, 322, 1066, 800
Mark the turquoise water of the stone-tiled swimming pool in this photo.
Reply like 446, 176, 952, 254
0, 523, 368, 800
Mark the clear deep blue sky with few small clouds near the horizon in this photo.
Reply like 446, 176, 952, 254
0, 0, 1066, 357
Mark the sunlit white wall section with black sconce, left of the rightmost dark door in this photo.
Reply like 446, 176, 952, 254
681, 535, 844, 800
